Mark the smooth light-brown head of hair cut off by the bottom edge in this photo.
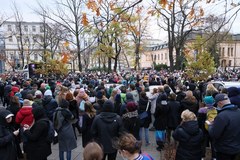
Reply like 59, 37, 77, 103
83, 142, 103, 160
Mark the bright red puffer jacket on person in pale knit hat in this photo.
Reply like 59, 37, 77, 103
15, 106, 33, 126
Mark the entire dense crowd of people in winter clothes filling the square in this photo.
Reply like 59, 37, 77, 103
0, 71, 240, 160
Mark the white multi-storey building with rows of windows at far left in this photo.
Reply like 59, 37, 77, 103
1, 21, 44, 71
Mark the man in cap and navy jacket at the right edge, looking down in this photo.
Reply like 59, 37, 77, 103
208, 93, 240, 160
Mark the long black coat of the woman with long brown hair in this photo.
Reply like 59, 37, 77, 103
82, 113, 94, 147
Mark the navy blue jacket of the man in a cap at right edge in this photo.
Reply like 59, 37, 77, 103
208, 104, 240, 154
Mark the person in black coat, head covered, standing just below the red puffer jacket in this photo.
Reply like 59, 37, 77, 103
23, 107, 52, 160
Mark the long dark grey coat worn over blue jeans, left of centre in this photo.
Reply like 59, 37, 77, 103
56, 107, 77, 151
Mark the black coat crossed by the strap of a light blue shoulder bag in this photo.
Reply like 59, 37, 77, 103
138, 97, 152, 128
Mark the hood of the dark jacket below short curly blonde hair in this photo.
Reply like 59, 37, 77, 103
182, 121, 199, 135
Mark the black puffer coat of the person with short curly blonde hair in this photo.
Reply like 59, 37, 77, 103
173, 121, 203, 160
